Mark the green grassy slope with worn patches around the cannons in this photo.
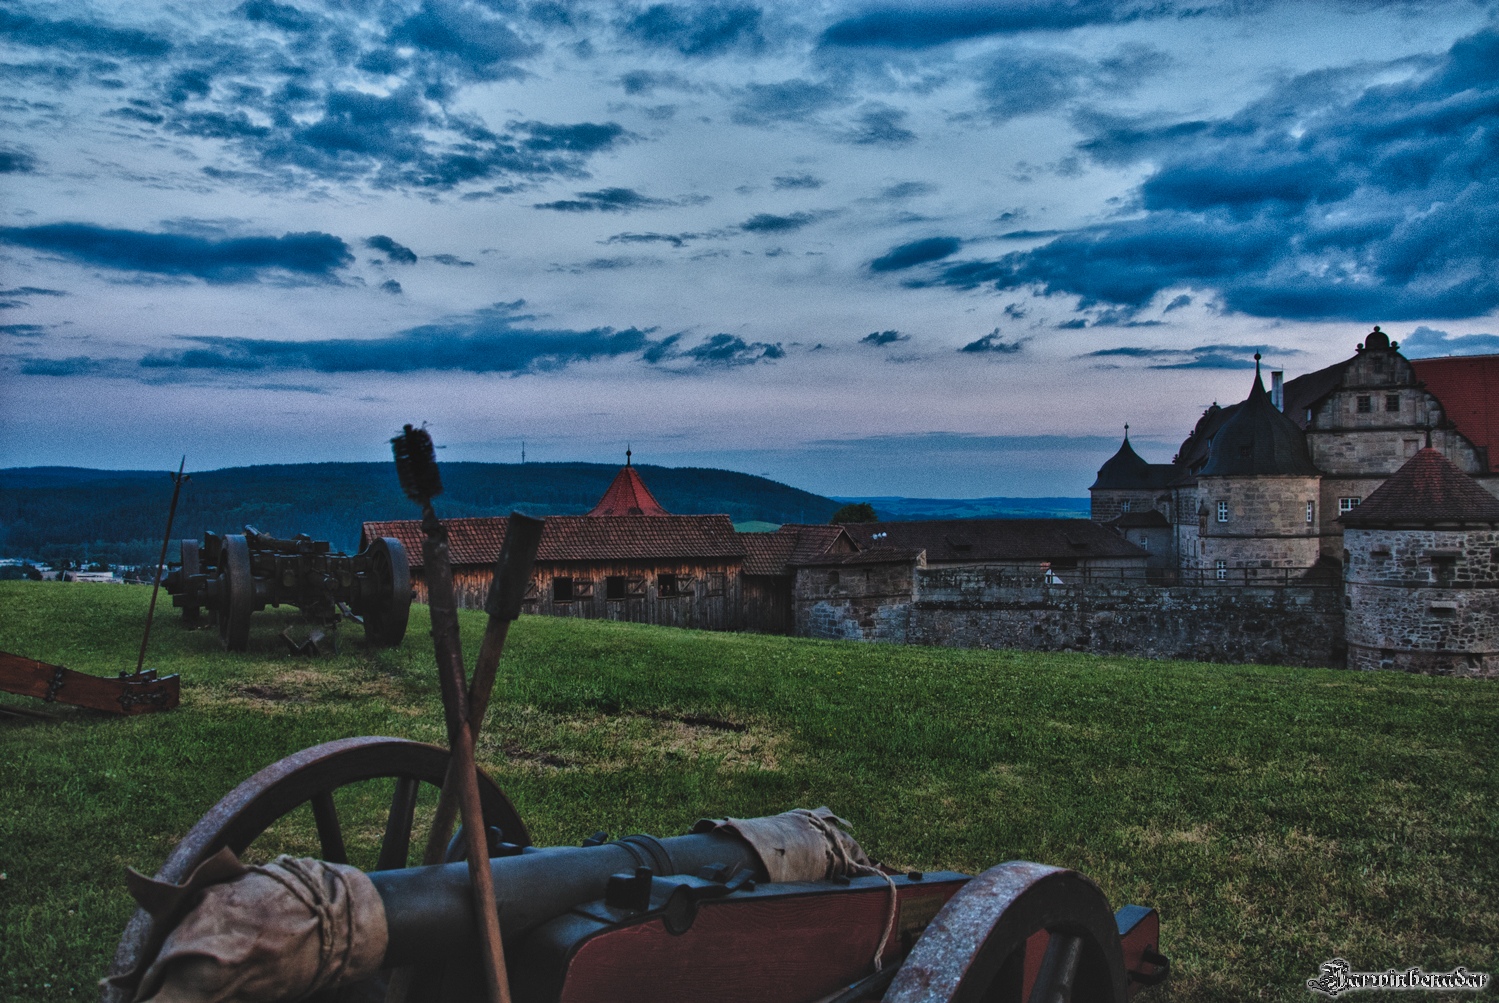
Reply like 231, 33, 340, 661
0, 583, 1499, 1000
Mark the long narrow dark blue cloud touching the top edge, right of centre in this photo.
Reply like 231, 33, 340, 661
821, 0, 1174, 49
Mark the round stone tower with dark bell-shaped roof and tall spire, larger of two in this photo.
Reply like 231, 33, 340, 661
1184, 355, 1322, 580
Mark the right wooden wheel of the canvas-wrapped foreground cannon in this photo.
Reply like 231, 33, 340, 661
884, 861, 1129, 1003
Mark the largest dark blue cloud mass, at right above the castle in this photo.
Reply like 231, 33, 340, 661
911, 30, 1499, 321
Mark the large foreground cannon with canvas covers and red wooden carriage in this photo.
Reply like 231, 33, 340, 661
103, 738, 1169, 1003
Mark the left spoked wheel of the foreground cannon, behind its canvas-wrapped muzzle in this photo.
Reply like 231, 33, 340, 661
100, 734, 531, 1003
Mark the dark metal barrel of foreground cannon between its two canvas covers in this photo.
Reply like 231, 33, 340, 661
369, 832, 764, 967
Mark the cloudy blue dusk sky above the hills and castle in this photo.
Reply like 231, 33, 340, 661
0, 0, 1499, 496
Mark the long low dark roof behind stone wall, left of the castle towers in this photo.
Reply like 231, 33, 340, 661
844, 519, 1147, 564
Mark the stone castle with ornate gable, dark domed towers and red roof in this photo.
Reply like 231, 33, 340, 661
1090, 327, 1499, 583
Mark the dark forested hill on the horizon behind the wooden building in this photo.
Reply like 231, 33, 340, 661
0, 463, 838, 564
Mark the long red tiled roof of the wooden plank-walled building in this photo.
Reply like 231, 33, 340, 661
360, 516, 745, 568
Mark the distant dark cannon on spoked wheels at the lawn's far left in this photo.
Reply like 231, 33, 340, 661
162, 526, 411, 651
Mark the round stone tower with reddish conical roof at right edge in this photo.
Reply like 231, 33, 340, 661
1339, 447, 1499, 676
